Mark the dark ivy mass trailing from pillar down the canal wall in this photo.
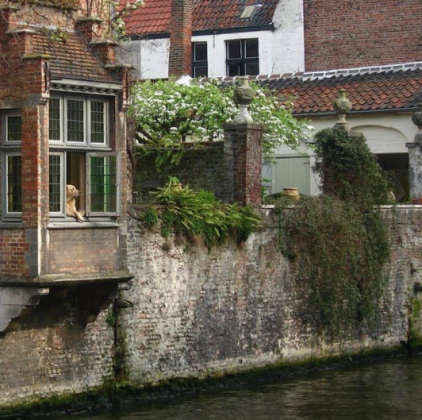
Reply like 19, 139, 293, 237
277, 130, 390, 339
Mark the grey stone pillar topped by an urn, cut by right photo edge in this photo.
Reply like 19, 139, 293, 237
406, 103, 422, 204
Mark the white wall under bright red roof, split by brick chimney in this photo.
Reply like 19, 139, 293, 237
118, 0, 305, 79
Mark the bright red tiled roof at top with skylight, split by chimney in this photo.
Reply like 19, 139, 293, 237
120, 0, 279, 35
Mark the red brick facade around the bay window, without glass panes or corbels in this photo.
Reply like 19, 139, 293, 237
0, 4, 128, 282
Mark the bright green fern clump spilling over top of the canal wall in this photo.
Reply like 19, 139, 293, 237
148, 183, 261, 249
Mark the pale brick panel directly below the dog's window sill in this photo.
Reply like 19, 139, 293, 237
45, 228, 120, 274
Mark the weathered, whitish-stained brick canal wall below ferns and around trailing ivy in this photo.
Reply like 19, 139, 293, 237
120, 208, 422, 383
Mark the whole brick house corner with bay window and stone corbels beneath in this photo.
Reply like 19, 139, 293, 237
0, 2, 130, 332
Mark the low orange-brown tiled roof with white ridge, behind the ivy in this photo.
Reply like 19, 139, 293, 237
223, 62, 422, 115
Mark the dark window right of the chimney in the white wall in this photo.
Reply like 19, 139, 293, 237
226, 38, 259, 76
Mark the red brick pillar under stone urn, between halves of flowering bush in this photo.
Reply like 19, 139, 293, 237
224, 123, 263, 207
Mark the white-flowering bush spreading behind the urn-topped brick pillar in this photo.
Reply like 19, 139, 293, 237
130, 79, 307, 168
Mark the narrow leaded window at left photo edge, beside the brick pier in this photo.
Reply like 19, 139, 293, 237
1, 111, 22, 218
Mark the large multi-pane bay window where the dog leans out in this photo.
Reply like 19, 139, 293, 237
49, 96, 119, 217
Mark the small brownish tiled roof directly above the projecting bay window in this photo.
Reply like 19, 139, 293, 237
32, 32, 113, 82
